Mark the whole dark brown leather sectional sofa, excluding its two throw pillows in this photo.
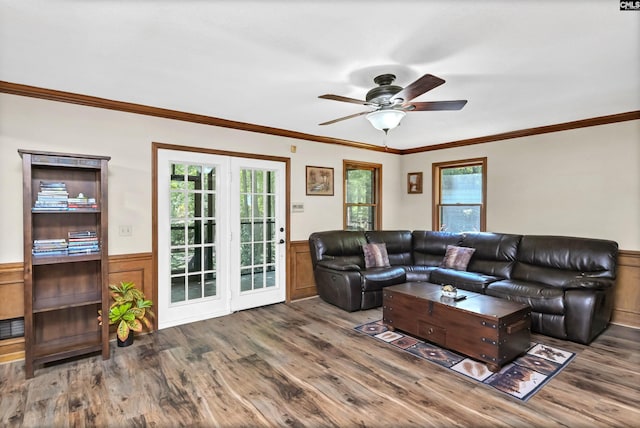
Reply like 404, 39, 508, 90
309, 230, 618, 344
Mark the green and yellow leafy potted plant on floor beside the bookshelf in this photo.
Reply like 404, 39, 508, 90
98, 281, 155, 346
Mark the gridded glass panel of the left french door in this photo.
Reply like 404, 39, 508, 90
169, 163, 217, 304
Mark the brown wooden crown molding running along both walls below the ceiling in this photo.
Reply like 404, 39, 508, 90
0, 81, 640, 155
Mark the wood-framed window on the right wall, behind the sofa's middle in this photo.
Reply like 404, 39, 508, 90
432, 158, 487, 232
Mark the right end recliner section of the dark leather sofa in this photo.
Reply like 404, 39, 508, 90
486, 236, 618, 343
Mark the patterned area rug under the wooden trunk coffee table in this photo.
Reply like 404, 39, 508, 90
355, 320, 576, 401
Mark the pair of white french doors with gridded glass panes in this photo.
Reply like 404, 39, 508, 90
157, 149, 286, 328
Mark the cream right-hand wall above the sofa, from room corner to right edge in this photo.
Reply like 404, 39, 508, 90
402, 120, 640, 250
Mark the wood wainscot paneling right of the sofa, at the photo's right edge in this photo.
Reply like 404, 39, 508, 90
611, 250, 640, 328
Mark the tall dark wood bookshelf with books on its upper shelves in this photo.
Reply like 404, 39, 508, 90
18, 150, 110, 378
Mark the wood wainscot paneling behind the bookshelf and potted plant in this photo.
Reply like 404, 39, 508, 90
0, 253, 157, 363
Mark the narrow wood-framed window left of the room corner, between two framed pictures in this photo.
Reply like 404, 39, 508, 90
343, 161, 382, 230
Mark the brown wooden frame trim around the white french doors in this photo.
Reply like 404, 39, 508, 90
151, 142, 291, 330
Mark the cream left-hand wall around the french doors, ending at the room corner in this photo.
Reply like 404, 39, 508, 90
0, 94, 401, 263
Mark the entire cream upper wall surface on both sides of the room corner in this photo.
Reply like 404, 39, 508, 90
0, 94, 640, 263
